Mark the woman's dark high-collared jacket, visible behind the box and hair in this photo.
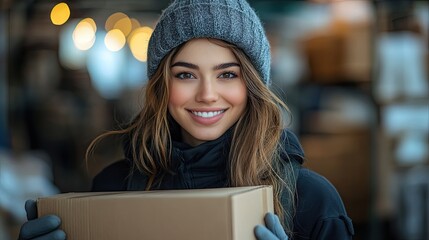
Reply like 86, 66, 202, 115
92, 131, 354, 240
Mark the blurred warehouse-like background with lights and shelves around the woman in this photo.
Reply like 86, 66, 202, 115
0, 0, 429, 240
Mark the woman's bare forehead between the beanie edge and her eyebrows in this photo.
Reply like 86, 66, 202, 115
173, 38, 237, 65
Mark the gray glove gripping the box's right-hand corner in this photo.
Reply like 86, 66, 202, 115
255, 213, 289, 240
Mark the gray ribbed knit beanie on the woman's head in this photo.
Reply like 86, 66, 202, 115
147, 0, 271, 85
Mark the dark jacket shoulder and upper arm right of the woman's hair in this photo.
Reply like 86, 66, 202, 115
294, 168, 354, 239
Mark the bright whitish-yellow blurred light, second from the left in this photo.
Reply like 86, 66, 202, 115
73, 19, 95, 50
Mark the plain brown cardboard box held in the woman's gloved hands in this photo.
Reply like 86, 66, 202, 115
37, 186, 273, 240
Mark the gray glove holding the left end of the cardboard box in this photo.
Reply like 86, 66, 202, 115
18, 200, 66, 240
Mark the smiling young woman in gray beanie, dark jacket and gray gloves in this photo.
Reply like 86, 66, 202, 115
20, 0, 353, 240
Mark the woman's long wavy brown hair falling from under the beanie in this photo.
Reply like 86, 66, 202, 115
86, 39, 295, 235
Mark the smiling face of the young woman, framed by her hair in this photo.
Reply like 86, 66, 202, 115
168, 39, 247, 146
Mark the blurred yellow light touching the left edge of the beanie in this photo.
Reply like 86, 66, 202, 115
128, 27, 153, 62
